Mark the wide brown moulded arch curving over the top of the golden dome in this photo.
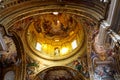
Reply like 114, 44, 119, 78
0, 1, 104, 33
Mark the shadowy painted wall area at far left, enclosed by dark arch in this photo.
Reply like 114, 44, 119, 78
0, 26, 22, 80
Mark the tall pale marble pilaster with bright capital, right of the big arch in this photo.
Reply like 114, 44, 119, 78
97, 0, 118, 46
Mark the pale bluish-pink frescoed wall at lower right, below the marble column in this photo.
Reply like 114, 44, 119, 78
90, 33, 116, 80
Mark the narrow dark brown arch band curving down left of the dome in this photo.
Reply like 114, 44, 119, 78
7, 32, 26, 80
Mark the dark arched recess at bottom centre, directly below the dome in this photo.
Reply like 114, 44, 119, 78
34, 66, 85, 80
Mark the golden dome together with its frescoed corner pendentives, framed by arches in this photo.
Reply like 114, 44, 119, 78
5, 12, 97, 80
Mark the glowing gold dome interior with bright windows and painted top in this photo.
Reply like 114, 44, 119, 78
26, 12, 84, 59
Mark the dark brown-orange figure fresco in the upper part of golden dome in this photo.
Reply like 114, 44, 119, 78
33, 13, 78, 38
